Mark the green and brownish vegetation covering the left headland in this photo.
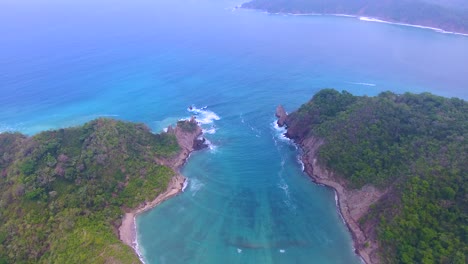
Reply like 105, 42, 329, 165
0, 119, 179, 263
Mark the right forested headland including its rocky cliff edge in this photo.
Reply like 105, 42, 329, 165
276, 89, 468, 264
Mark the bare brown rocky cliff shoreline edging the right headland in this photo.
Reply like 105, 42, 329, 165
276, 105, 386, 264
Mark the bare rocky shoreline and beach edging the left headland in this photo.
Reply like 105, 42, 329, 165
118, 117, 206, 259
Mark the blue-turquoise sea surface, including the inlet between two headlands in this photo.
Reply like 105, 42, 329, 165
0, 0, 468, 264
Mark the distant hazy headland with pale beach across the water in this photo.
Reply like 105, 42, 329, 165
241, 0, 468, 34
